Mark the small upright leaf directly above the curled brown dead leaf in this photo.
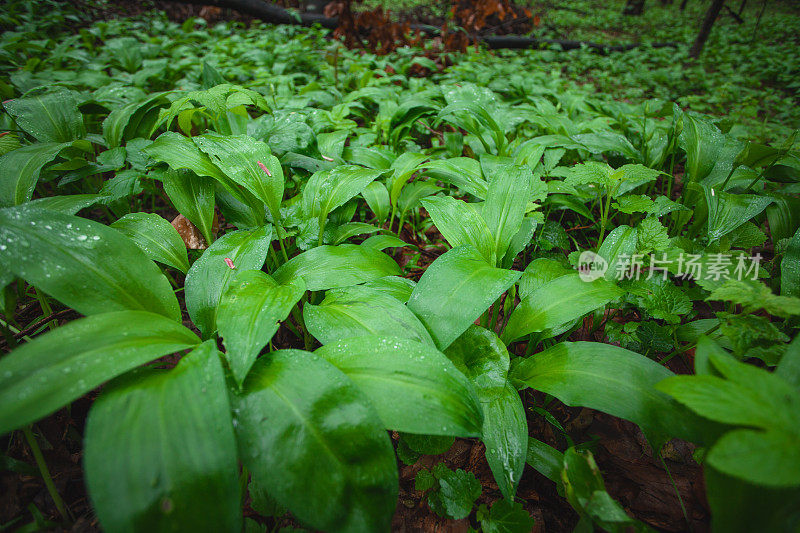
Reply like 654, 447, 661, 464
160, 169, 214, 248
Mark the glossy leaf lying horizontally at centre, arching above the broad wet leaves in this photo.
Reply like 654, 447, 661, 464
273, 244, 400, 291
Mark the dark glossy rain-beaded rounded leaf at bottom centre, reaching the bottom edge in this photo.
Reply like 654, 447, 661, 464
232, 350, 398, 531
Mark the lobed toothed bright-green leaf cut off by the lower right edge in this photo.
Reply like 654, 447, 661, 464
658, 337, 800, 487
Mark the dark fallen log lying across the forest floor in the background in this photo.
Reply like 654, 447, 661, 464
172, 0, 680, 54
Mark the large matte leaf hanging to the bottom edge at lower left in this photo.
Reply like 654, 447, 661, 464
84, 341, 242, 531
